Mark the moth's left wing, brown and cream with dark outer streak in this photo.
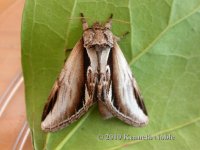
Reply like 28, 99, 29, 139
41, 39, 93, 131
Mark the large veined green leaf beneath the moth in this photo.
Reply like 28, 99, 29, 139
22, 0, 200, 150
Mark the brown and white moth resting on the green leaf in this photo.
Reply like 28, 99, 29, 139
41, 14, 148, 132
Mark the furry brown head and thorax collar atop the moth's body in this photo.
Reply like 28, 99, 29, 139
83, 23, 113, 49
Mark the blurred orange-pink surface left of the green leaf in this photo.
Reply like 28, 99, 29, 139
0, 0, 32, 150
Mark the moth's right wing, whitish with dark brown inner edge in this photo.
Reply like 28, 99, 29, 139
106, 43, 148, 127
